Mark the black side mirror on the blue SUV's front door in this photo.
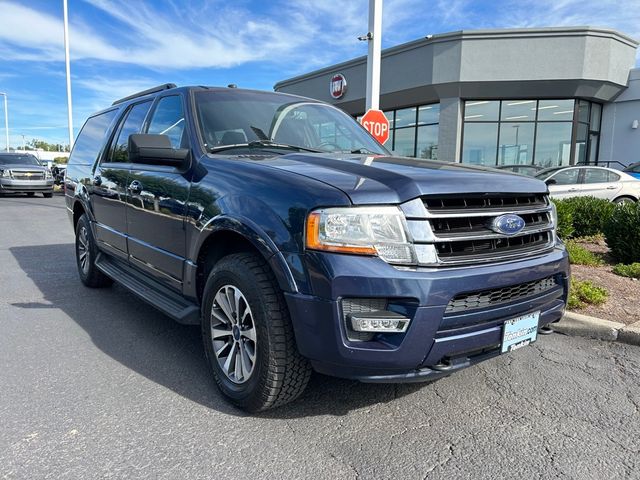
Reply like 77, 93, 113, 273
128, 133, 189, 168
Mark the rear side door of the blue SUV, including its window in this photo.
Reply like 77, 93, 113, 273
91, 101, 151, 260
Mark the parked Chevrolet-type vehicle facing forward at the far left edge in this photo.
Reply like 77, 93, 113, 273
0, 153, 53, 198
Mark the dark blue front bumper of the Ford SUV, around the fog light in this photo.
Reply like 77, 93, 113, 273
285, 246, 569, 382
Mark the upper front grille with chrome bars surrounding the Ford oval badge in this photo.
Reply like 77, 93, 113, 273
402, 193, 554, 266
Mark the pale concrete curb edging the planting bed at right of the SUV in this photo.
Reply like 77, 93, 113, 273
550, 312, 640, 345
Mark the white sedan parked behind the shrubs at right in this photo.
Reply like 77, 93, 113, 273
536, 166, 640, 203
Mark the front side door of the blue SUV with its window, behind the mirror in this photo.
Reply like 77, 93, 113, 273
127, 94, 190, 291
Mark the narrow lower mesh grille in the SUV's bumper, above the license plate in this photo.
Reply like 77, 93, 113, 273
445, 277, 558, 314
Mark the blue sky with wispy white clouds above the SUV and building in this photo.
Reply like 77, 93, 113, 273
0, 0, 640, 147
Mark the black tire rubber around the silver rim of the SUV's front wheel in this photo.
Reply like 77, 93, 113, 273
202, 253, 311, 412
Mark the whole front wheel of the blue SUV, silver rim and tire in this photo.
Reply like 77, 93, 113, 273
202, 253, 311, 412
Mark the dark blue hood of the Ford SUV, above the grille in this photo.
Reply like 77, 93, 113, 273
262, 153, 547, 205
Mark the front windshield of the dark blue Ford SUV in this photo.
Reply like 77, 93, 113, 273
195, 90, 388, 155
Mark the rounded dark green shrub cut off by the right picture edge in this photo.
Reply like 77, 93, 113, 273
604, 202, 640, 264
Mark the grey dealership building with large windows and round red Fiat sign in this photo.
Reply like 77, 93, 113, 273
275, 27, 640, 167
